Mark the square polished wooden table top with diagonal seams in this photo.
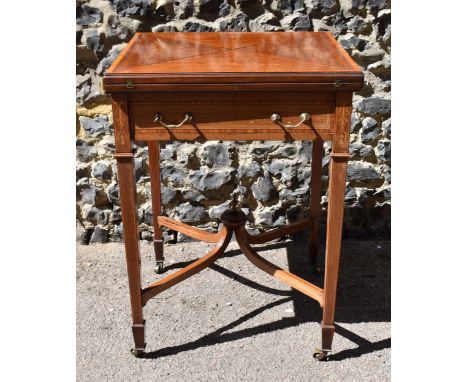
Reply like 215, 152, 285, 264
104, 32, 363, 90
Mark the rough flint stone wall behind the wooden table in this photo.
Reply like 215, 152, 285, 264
76, 0, 391, 242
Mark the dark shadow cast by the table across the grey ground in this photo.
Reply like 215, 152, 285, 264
143, 235, 391, 361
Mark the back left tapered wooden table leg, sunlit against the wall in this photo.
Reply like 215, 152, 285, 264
148, 141, 164, 273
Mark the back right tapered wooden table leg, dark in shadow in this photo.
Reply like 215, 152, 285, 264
309, 138, 323, 274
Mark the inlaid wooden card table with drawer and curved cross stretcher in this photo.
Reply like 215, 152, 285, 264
104, 32, 363, 360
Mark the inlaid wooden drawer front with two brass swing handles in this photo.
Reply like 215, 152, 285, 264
130, 92, 335, 141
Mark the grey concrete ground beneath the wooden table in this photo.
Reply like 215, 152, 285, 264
76, 230, 390, 382
